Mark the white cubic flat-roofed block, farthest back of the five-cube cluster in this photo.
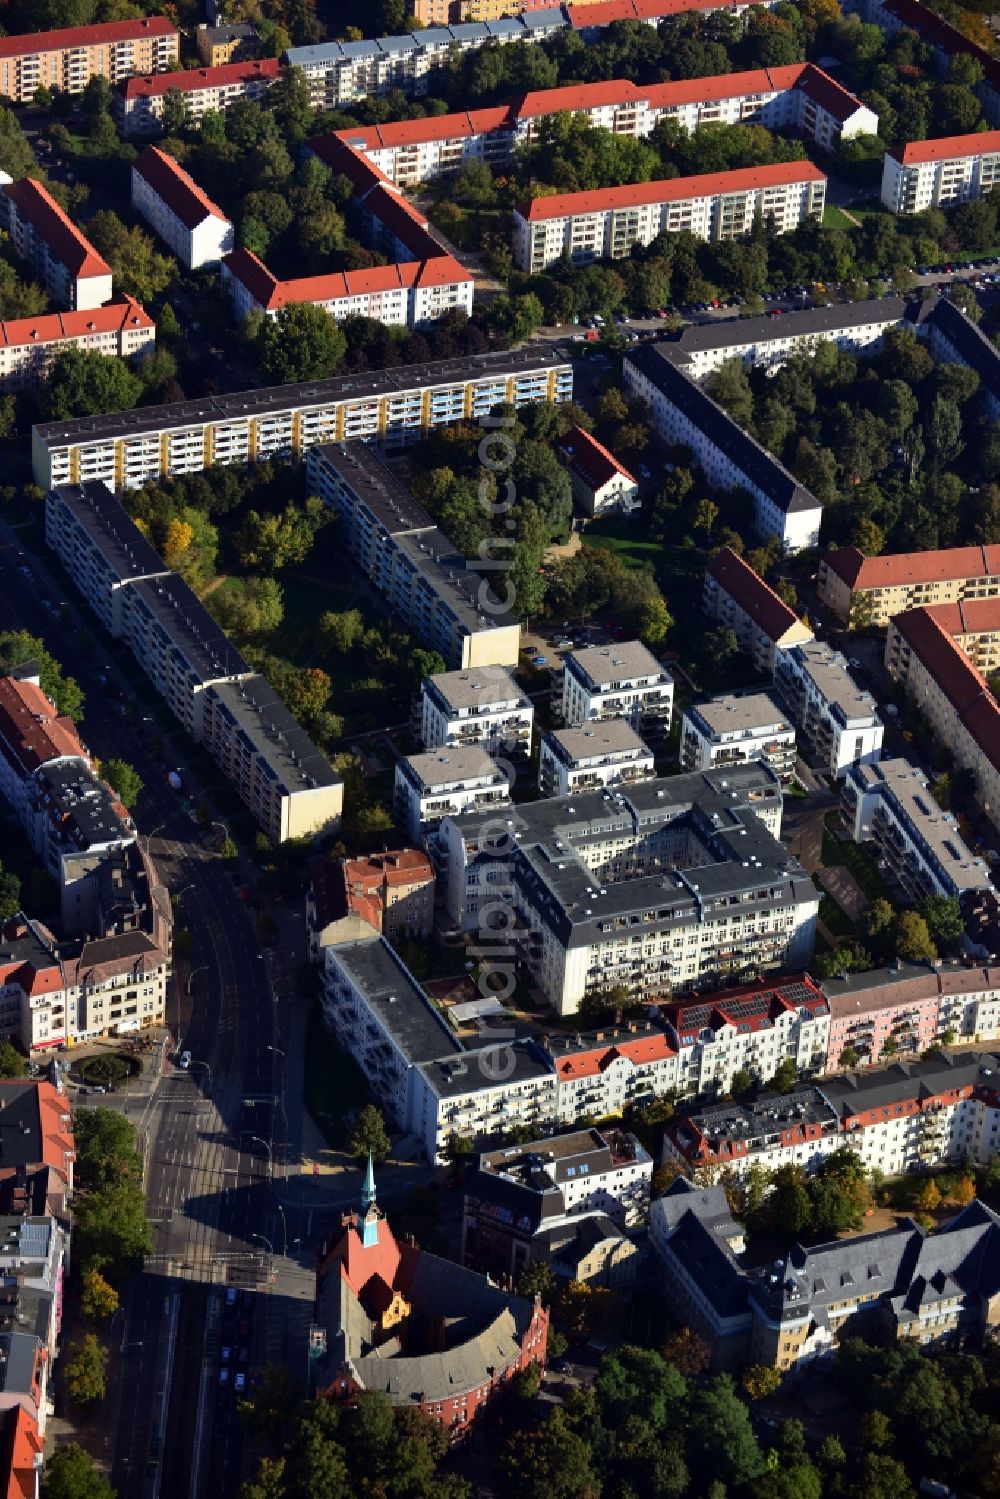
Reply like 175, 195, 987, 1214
553, 640, 673, 739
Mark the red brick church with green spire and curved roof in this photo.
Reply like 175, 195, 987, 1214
315, 1159, 549, 1436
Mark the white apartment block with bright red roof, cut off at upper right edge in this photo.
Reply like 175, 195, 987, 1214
882, 130, 1000, 213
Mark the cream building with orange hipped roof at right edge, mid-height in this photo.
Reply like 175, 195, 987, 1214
817, 546, 1000, 630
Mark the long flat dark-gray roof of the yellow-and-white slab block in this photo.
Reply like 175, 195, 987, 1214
33, 343, 570, 447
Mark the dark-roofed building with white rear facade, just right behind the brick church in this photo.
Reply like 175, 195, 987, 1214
462, 1129, 652, 1286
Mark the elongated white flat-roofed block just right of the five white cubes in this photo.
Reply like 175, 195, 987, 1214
774, 640, 885, 779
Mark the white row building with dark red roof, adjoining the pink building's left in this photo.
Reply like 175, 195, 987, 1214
661, 973, 831, 1099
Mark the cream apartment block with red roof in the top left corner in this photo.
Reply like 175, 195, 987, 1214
0, 15, 180, 103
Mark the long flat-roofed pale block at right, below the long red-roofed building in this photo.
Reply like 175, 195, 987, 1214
840, 760, 993, 905
